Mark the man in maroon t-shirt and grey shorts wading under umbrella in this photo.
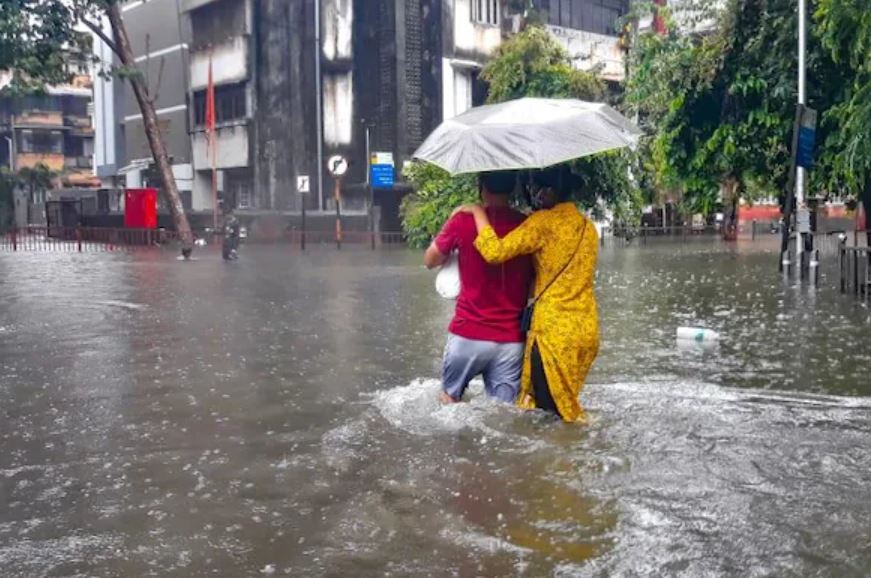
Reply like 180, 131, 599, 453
424, 172, 532, 403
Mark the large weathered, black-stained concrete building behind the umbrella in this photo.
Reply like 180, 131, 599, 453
95, 0, 629, 230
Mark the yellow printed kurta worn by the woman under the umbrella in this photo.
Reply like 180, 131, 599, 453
475, 203, 599, 421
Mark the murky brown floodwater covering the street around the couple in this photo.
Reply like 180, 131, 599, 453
0, 242, 871, 578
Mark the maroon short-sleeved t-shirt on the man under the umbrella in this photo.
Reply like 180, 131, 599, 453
435, 208, 532, 343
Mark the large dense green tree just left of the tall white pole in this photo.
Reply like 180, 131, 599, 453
627, 0, 837, 235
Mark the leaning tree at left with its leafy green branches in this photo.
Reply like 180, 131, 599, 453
0, 0, 193, 255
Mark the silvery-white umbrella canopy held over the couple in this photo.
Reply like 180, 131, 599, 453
414, 98, 641, 175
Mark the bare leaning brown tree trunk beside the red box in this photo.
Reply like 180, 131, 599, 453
107, 2, 193, 258
